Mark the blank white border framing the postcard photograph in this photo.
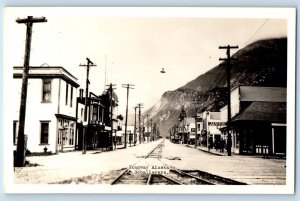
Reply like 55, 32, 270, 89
3, 7, 296, 194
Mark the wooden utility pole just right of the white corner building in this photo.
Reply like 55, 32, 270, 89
79, 58, 96, 154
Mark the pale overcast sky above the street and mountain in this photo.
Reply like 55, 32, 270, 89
5, 8, 287, 113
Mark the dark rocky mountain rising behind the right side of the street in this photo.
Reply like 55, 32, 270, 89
144, 38, 287, 136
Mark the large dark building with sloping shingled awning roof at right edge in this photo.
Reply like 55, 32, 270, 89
220, 86, 287, 155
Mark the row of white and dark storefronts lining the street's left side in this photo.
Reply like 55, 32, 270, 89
12, 66, 122, 153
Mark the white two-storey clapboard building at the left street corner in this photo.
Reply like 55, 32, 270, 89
12, 66, 79, 153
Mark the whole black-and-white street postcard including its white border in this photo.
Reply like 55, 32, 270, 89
3, 7, 296, 194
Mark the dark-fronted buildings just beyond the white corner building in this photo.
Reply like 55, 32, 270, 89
76, 89, 122, 150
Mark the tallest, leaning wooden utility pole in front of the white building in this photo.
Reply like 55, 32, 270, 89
15, 16, 47, 167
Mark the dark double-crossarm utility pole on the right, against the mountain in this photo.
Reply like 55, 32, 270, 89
219, 45, 239, 156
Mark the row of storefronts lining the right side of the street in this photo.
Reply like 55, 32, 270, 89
170, 86, 287, 155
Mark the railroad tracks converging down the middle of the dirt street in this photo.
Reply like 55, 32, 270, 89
111, 140, 245, 185
